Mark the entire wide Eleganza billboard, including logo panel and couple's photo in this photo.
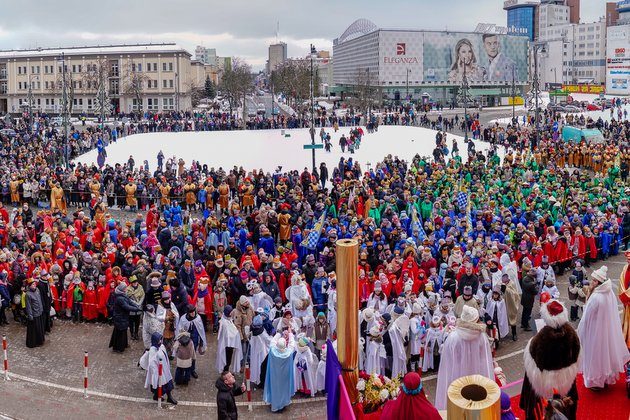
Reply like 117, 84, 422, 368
379, 30, 528, 87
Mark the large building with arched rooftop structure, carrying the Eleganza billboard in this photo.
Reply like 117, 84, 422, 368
331, 19, 529, 105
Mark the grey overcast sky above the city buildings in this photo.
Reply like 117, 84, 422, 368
0, 0, 606, 69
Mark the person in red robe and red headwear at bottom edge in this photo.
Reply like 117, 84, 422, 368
381, 372, 442, 420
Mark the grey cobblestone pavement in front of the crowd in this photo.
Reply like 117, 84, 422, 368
0, 255, 624, 419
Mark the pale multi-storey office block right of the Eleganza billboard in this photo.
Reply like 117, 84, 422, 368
532, 19, 606, 88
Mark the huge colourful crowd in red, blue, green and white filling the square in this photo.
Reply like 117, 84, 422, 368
0, 98, 630, 411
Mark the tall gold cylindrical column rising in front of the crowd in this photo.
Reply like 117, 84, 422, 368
336, 239, 359, 405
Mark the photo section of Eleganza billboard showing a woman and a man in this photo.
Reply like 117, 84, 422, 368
423, 32, 528, 85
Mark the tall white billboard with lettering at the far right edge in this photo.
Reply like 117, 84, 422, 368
606, 25, 630, 95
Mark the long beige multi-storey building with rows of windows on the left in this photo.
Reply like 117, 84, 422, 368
0, 44, 199, 114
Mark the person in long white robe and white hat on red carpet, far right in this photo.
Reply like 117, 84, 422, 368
578, 265, 630, 389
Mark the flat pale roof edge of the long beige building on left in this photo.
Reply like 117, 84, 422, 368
0, 43, 190, 58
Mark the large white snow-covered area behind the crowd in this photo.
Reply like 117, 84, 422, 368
75, 126, 489, 173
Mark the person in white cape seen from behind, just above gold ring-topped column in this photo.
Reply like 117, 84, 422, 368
435, 306, 494, 410
